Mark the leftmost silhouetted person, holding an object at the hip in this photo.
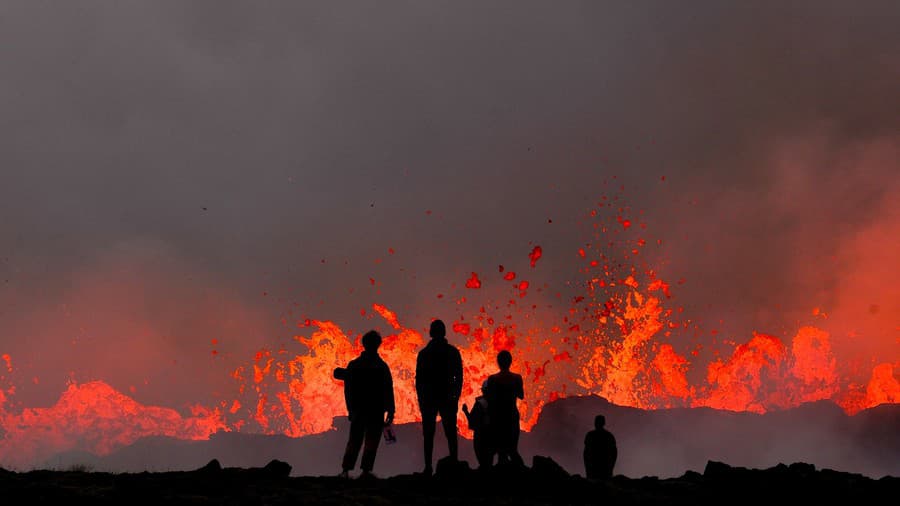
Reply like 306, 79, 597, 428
334, 330, 394, 478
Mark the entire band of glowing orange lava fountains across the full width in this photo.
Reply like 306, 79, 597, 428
0, 193, 900, 467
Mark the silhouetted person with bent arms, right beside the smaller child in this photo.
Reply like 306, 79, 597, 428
485, 350, 525, 466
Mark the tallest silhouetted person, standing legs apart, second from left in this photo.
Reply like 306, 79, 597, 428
416, 320, 463, 475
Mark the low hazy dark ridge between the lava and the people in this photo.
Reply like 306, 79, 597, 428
42, 396, 900, 478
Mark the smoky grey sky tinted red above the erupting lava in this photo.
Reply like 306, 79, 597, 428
0, 1, 900, 406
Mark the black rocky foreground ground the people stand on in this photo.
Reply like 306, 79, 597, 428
0, 457, 900, 505
